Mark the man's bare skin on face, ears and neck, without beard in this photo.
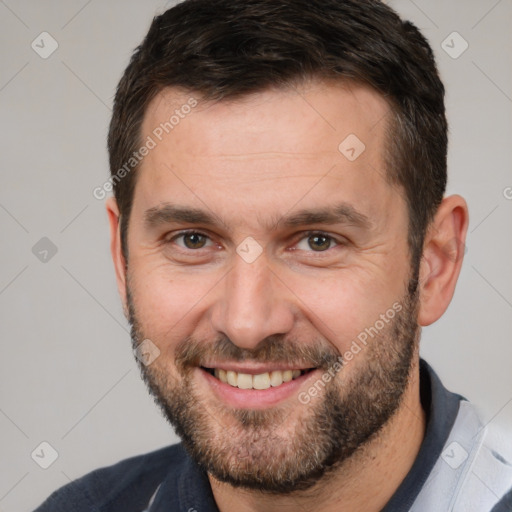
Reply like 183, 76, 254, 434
107, 82, 468, 512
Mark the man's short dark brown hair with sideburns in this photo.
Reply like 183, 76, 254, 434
108, 0, 448, 268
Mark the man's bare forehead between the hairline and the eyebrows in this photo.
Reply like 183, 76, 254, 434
134, 82, 402, 232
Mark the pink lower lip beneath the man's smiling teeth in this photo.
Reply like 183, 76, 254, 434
196, 368, 319, 409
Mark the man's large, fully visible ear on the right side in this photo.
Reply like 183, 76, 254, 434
418, 195, 469, 326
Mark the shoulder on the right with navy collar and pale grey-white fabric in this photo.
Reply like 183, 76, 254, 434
412, 361, 512, 512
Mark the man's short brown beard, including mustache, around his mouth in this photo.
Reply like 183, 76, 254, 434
127, 280, 420, 495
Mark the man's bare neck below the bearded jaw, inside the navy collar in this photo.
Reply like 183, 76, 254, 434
209, 358, 426, 512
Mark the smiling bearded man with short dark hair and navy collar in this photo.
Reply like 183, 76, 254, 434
38, 0, 512, 512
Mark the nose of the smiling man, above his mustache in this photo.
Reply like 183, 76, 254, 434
211, 254, 294, 350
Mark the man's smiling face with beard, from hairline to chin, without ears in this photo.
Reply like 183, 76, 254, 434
122, 83, 417, 492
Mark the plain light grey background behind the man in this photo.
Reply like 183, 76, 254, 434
0, 0, 512, 512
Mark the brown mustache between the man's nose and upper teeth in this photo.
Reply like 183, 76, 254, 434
175, 335, 342, 371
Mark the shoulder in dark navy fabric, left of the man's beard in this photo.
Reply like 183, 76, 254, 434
35, 444, 187, 512
